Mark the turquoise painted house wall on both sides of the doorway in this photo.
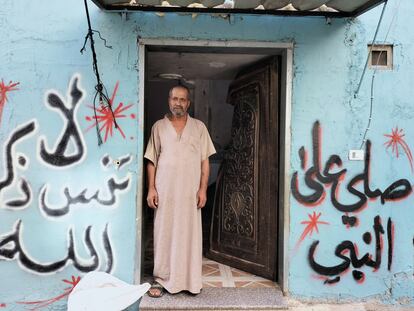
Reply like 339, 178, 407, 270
0, 0, 414, 310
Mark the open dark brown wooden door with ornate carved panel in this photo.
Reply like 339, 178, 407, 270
207, 57, 280, 280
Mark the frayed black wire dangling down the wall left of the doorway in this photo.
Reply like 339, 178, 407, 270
80, 0, 118, 146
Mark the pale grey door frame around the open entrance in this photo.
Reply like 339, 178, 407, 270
134, 38, 294, 294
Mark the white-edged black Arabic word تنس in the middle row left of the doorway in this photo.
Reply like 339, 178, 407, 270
39, 178, 129, 217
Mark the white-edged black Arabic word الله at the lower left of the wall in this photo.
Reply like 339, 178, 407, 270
0, 220, 113, 273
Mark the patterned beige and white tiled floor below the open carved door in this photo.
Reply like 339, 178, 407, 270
203, 258, 277, 288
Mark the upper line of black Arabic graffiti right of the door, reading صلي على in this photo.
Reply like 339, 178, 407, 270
291, 121, 412, 212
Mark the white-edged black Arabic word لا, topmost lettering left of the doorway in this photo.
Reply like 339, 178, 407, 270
40, 77, 85, 167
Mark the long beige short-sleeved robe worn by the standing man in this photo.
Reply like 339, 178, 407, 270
144, 116, 216, 294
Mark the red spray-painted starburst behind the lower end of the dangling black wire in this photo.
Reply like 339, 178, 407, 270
85, 82, 132, 142
